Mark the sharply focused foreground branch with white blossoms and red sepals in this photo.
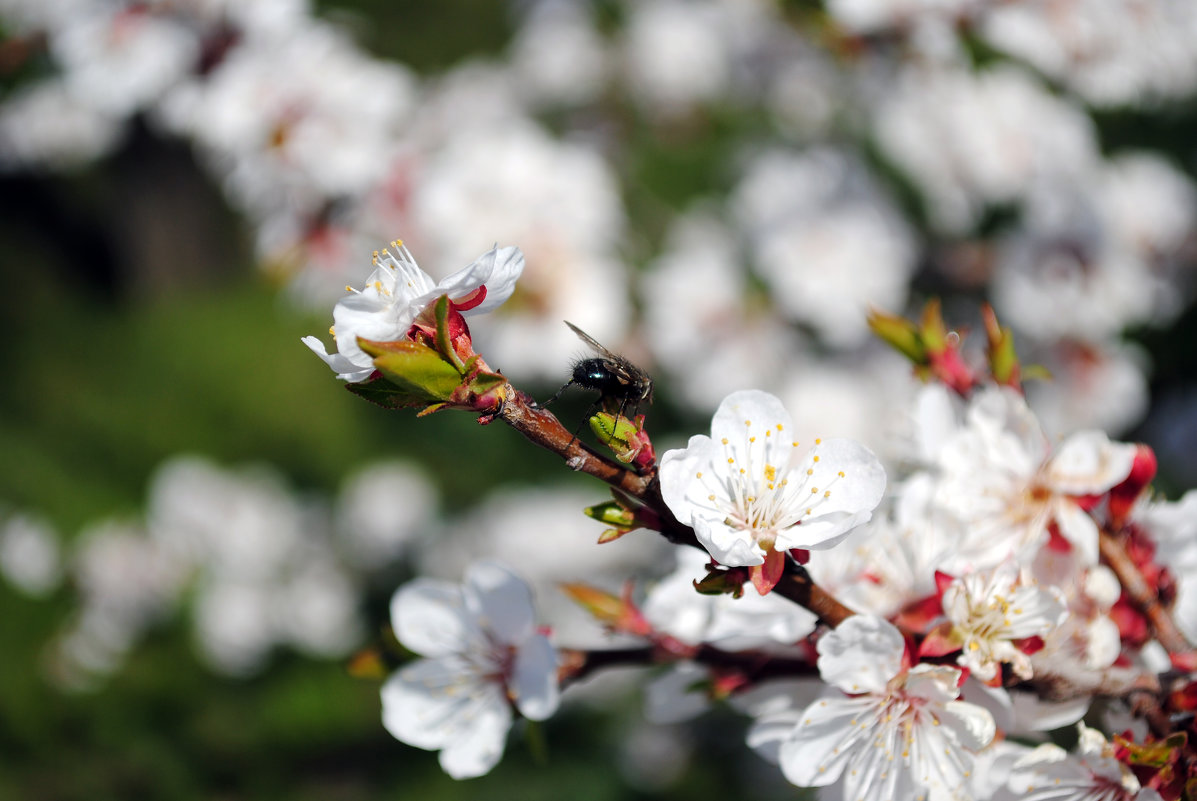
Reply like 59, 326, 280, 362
280, 239, 1197, 801
